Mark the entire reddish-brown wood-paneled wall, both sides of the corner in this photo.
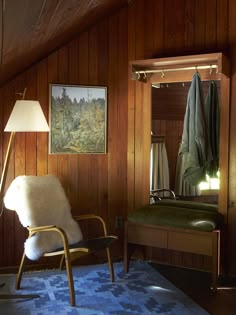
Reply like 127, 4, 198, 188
0, 0, 236, 274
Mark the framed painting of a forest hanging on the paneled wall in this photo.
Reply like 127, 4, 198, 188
50, 85, 107, 154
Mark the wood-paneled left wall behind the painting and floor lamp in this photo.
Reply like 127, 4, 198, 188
0, 8, 128, 267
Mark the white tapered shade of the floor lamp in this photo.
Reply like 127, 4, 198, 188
4, 100, 49, 132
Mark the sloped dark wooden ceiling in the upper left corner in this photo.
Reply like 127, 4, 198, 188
0, 0, 128, 85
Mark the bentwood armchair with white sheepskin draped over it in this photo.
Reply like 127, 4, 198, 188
4, 175, 117, 306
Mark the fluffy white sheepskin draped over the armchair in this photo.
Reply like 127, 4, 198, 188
4, 175, 82, 260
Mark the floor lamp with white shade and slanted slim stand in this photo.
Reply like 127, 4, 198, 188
0, 89, 49, 299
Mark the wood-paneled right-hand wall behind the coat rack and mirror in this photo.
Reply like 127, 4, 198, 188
128, 0, 236, 274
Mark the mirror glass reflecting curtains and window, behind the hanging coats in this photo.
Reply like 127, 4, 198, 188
150, 80, 220, 203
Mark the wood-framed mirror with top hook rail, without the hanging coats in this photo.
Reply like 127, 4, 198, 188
130, 53, 230, 222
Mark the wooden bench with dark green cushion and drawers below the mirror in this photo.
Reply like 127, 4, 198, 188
124, 199, 224, 290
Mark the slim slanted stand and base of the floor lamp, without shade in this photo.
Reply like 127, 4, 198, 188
0, 89, 39, 300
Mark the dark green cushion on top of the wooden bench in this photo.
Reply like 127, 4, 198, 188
128, 200, 224, 232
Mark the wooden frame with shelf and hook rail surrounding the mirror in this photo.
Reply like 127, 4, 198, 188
129, 53, 230, 223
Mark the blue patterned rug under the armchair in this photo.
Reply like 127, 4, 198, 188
0, 261, 208, 315
